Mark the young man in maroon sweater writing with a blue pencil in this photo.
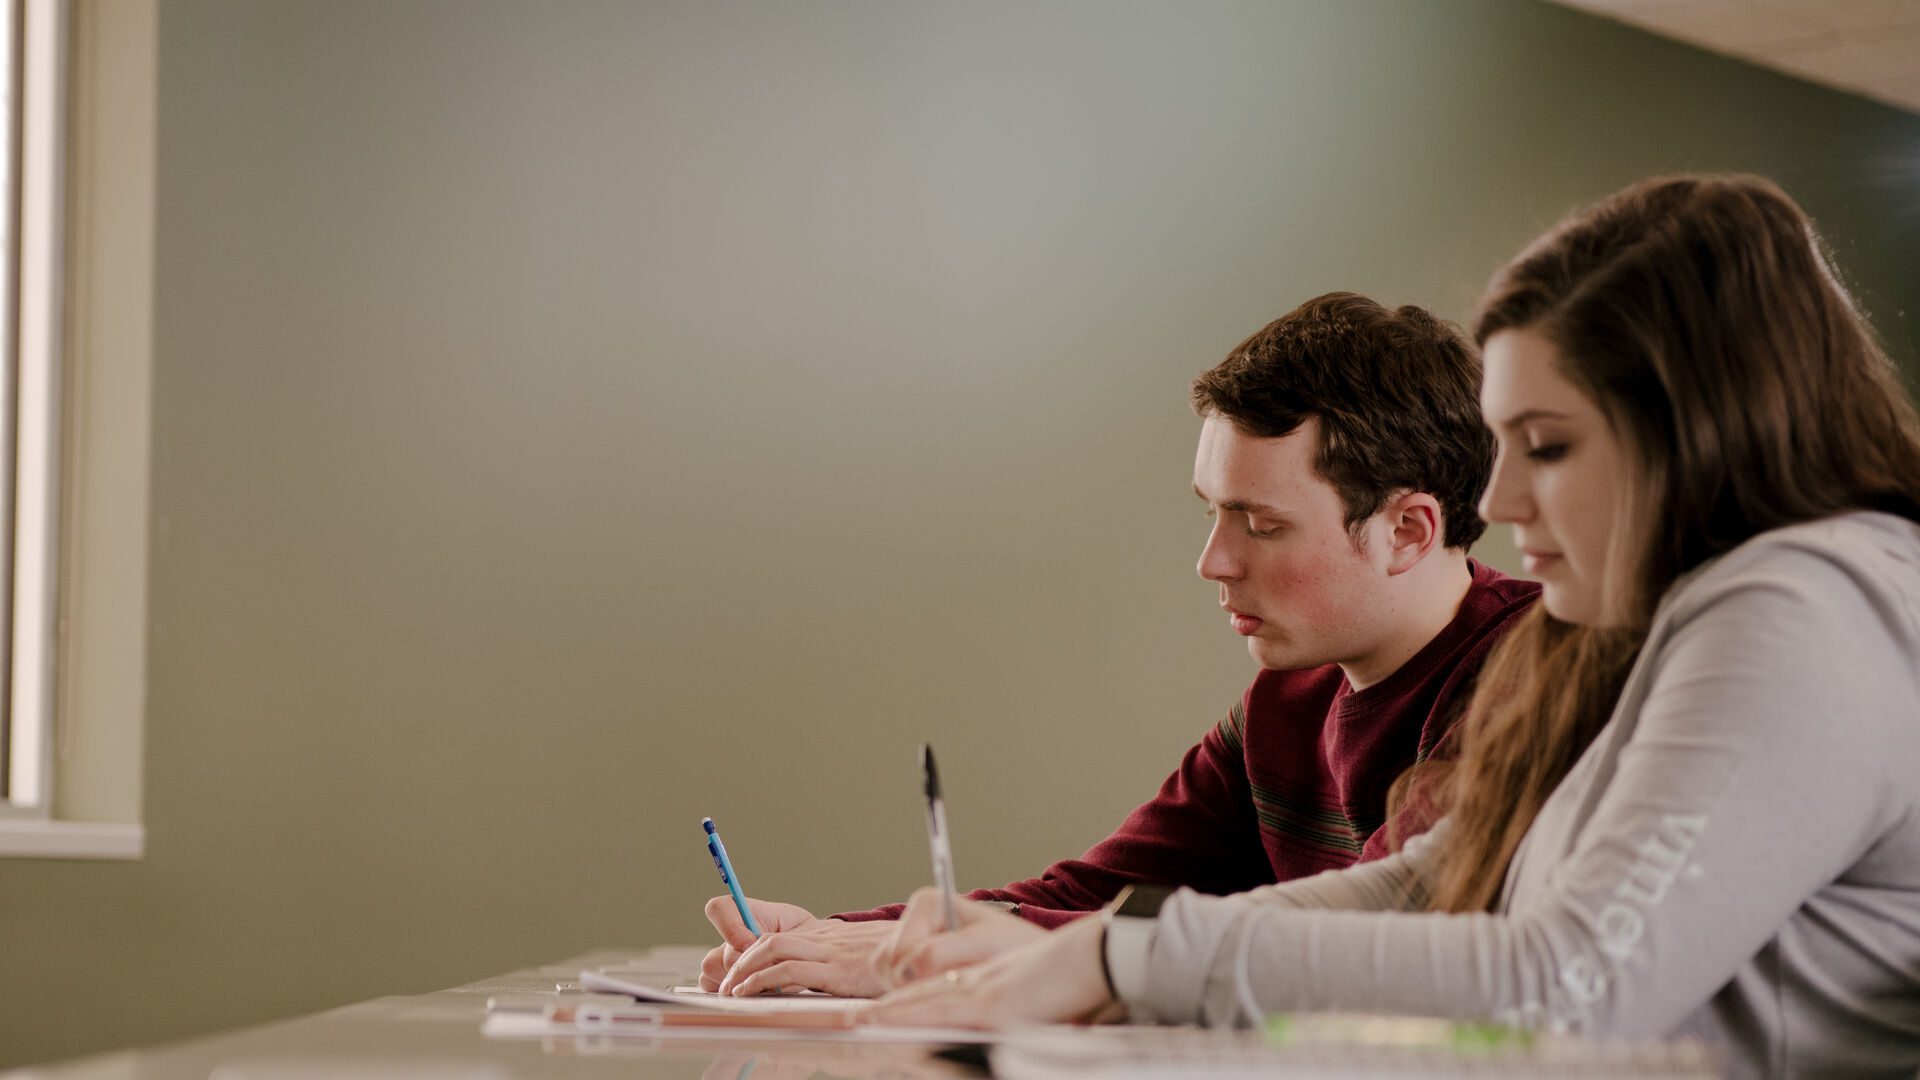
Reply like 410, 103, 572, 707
701, 292, 1540, 995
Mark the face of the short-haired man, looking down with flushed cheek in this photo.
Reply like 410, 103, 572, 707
1194, 409, 1392, 671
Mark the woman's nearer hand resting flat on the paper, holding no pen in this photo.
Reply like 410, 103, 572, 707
860, 907, 1114, 1028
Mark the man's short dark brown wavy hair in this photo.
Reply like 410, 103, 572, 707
1192, 292, 1494, 548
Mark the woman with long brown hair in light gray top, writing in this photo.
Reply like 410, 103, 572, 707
872, 177, 1920, 1074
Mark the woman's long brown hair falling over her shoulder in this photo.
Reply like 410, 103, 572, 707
1402, 177, 1920, 911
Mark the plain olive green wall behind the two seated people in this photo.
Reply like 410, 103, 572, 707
0, 0, 1920, 1065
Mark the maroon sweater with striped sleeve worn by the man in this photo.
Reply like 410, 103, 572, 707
833, 563, 1540, 926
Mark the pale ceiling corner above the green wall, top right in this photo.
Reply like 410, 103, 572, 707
1553, 0, 1920, 113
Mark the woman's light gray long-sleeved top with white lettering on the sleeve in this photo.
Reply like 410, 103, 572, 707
1108, 513, 1920, 1076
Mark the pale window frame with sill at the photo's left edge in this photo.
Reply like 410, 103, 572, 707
0, 0, 159, 859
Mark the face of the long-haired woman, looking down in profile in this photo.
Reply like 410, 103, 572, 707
1480, 331, 1632, 626
